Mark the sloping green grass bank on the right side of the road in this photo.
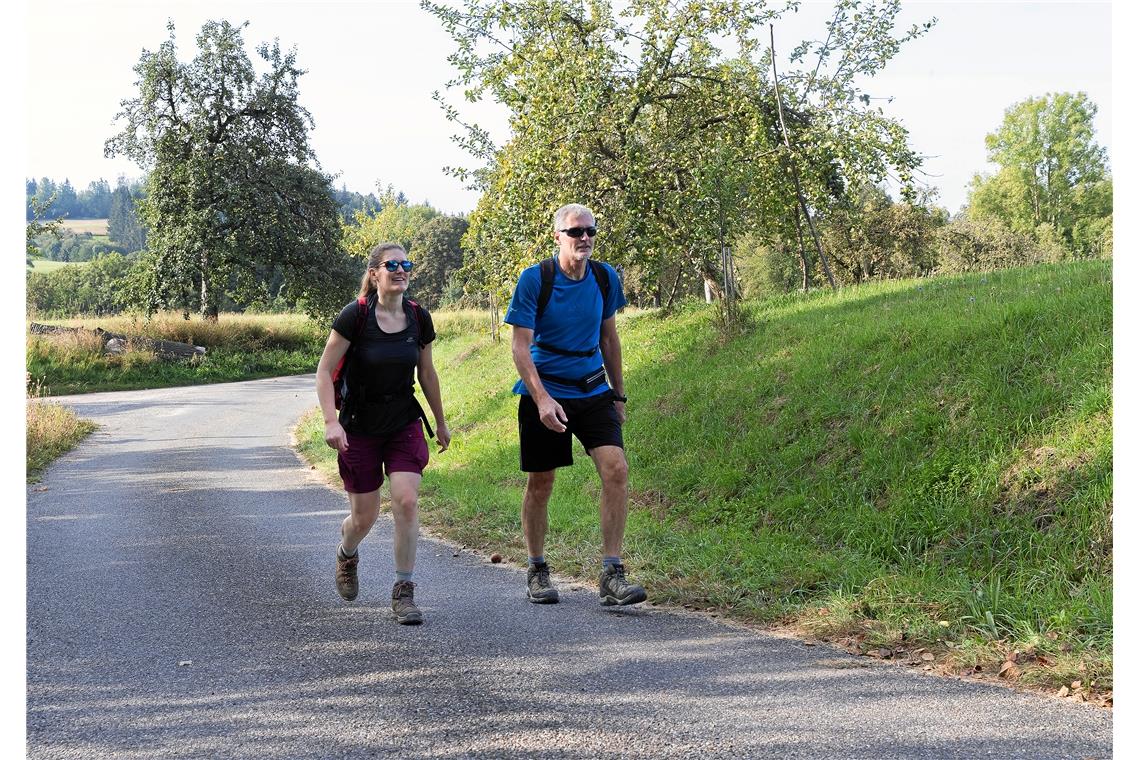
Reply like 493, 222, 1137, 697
299, 261, 1113, 687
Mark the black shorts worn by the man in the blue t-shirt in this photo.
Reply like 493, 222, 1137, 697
519, 391, 625, 473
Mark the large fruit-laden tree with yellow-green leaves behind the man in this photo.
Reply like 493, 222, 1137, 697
422, 0, 929, 303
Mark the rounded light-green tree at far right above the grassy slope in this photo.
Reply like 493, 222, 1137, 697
967, 92, 1113, 255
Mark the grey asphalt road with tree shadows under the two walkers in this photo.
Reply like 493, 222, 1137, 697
27, 375, 1113, 760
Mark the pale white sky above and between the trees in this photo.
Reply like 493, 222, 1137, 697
24, 0, 1113, 213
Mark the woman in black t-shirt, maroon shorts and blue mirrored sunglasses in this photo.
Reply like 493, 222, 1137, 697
317, 243, 451, 624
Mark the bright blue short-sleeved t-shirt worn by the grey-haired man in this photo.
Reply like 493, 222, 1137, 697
503, 256, 626, 399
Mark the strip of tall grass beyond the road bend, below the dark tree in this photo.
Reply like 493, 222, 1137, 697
26, 314, 328, 395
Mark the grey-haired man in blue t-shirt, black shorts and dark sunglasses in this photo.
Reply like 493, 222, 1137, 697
504, 204, 645, 605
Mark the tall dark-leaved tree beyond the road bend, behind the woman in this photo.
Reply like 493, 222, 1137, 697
105, 21, 349, 319
